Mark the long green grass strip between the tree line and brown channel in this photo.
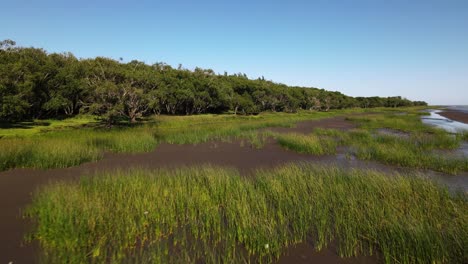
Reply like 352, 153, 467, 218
0, 110, 354, 171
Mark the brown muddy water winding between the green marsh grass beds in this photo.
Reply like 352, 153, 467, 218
0, 118, 467, 263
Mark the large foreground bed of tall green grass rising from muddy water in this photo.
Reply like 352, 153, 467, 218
28, 165, 468, 263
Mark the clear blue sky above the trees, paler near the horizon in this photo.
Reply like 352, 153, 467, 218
0, 0, 468, 105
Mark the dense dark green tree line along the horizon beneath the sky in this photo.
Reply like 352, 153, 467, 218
0, 40, 427, 124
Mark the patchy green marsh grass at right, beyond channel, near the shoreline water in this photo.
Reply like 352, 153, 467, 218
277, 113, 468, 174
